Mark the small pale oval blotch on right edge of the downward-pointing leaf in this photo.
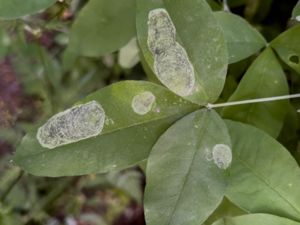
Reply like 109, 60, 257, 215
212, 144, 232, 169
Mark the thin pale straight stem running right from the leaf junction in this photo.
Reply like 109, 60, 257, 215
206, 93, 300, 109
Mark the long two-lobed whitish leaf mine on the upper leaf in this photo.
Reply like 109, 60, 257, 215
147, 8, 195, 96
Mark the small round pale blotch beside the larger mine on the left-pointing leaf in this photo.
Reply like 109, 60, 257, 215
131, 91, 155, 115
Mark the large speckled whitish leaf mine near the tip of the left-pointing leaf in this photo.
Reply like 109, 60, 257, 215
37, 101, 105, 149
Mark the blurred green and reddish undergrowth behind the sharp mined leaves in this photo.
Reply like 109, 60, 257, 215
0, 0, 300, 225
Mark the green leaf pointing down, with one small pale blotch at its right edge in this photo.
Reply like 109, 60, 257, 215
144, 109, 231, 225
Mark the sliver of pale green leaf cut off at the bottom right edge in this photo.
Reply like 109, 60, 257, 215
213, 214, 300, 225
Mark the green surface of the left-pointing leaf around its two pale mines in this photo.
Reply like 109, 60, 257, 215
14, 81, 197, 176
